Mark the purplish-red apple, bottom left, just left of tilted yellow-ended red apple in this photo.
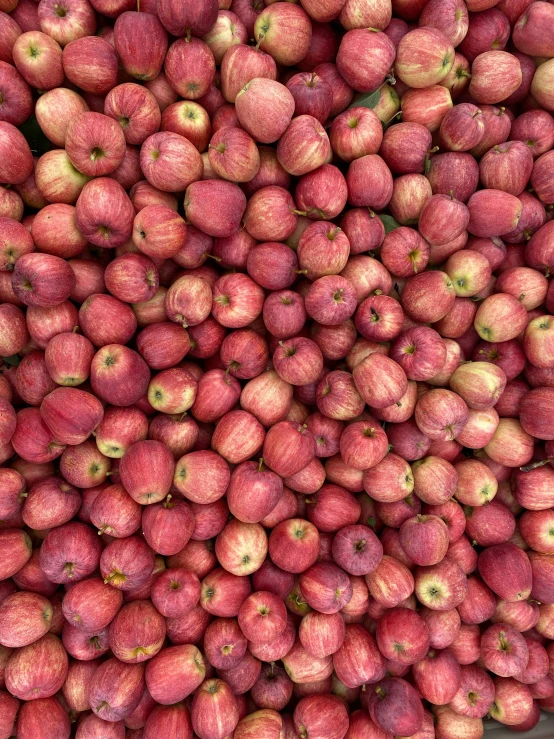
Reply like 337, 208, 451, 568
90, 657, 145, 721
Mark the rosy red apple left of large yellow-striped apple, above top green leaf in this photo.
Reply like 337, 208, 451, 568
337, 28, 396, 93
